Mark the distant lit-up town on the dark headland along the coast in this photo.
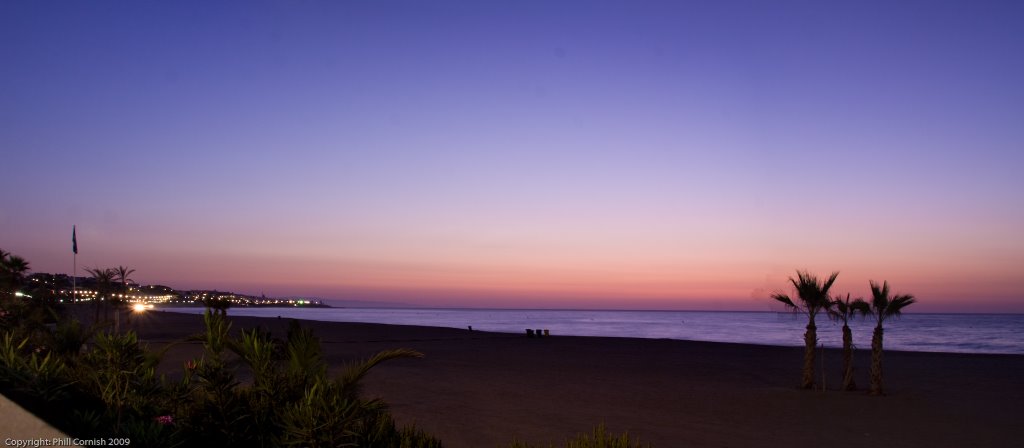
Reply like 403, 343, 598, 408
26, 273, 329, 308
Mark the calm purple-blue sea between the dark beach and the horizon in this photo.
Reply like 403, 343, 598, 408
167, 308, 1024, 354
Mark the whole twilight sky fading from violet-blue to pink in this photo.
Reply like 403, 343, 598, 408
0, 0, 1024, 312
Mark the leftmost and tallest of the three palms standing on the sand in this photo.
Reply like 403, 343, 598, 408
771, 271, 839, 389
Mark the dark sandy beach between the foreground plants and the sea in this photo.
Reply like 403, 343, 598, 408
123, 312, 1024, 448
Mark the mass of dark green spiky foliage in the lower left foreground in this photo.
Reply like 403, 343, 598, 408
0, 302, 432, 448
